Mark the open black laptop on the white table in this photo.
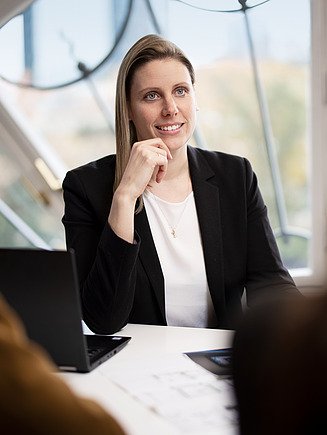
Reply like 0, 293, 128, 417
0, 248, 131, 372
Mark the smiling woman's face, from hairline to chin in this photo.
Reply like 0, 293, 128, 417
128, 59, 196, 151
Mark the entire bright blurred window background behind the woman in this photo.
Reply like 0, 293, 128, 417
0, 0, 327, 292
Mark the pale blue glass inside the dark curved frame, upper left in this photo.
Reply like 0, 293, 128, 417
0, 0, 131, 88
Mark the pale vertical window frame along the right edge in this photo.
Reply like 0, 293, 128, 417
298, 0, 327, 294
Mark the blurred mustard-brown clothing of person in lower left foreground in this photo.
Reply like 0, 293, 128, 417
0, 297, 125, 435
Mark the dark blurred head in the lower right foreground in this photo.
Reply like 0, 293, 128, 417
233, 295, 327, 435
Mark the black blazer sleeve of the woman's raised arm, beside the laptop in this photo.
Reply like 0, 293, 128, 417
62, 171, 140, 334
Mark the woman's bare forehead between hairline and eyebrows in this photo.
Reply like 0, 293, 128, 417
132, 59, 192, 90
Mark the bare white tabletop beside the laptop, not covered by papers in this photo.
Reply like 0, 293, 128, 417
60, 324, 237, 435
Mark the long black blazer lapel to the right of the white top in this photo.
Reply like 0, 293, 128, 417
188, 146, 226, 318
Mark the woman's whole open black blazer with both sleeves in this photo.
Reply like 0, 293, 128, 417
63, 146, 296, 334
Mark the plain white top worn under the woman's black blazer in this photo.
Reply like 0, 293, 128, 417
143, 191, 217, 328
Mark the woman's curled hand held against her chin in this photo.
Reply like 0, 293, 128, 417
117, 138, 172, 201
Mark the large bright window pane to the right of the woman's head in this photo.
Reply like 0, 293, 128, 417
168, 0, 311, 268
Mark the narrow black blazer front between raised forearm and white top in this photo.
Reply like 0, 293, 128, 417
134, 208, 166, 322
